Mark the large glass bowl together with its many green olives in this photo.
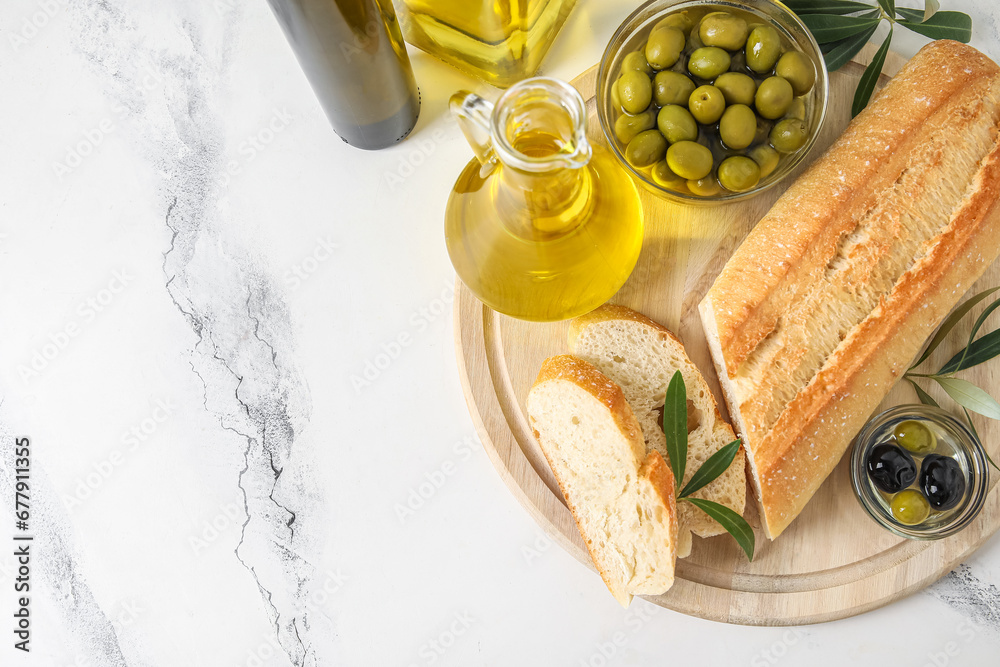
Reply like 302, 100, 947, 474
597, 0, 829, 203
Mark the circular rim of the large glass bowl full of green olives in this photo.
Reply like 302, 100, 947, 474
595, 0, 830, 204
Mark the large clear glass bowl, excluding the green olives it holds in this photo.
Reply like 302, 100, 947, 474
597, 0, 830, 204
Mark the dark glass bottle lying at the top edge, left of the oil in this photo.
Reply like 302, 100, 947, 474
268, 0, 420, 149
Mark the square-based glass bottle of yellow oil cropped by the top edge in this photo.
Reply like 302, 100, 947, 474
395, 0, 576, 88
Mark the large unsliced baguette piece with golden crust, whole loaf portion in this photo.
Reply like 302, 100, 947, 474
700, 40, 1000, 539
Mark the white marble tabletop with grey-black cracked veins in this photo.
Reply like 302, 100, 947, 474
0, 0, 1000, 667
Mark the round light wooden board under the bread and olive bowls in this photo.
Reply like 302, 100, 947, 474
455, 45, 1000, 625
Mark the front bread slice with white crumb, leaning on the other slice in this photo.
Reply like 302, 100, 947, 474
527, 355, 677, 606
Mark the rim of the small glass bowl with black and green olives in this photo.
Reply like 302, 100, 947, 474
850, 403, 990, 541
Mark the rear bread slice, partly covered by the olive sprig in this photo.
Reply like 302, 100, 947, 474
569, 304, 747, 558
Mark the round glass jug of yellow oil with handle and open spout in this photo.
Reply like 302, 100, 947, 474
445, 78, 643, 321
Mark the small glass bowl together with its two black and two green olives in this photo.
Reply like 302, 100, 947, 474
851, 405, 990, 540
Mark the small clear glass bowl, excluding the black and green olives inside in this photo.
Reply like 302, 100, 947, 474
851, 404, 990, 540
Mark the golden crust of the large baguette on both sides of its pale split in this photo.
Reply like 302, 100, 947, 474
700, 40, 1000, 539
